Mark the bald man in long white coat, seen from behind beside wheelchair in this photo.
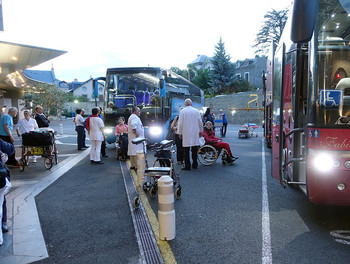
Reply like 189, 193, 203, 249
178, 99, 203, 170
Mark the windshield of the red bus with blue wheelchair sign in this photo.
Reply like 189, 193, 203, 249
315, 0, 350, 125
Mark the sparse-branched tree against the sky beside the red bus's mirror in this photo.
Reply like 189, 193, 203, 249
252, 8, 288, 55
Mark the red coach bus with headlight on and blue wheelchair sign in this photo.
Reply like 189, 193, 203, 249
264, 0, 350, 206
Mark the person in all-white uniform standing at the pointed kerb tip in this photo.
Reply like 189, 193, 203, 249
86, 108, 106, 164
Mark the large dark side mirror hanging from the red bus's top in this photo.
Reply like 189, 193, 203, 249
290, 0, 318, 43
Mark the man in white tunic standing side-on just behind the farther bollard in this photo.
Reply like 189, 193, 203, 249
128, 106, 145, 169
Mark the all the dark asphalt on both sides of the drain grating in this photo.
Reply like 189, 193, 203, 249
2, 120, 350, 263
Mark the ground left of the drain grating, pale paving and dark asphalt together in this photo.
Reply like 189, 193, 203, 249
0, 120, 141, 264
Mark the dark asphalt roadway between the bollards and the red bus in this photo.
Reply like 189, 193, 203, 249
140, 126, 350, 263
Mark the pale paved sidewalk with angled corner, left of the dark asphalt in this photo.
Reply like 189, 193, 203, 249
0, 120, 88, 263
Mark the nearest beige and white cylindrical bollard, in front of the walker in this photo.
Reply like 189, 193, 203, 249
158, 176, 175, 240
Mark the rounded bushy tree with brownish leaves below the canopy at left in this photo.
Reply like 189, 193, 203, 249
21, 83, 68, 117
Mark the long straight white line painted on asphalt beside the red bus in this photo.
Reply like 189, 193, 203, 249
261, 139, 272, 264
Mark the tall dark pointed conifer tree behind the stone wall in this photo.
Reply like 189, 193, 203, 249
210, 37, 234, 93
